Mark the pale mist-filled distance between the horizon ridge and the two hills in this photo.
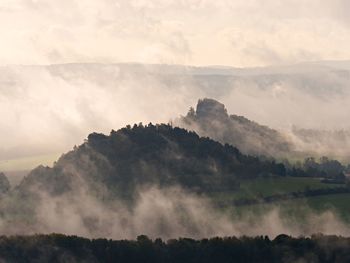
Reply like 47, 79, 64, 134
0, 63, 350, 167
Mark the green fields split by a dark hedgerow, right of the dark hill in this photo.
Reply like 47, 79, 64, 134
210, 177, 350, 223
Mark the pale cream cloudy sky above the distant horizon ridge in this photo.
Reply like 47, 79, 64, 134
0, 0, 350, 67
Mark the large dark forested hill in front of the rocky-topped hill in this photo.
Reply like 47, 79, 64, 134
19, 124, 285, 198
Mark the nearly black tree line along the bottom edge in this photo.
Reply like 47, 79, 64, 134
0, 234, 350, 263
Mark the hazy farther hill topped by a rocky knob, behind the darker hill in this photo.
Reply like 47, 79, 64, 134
175, 98, 294, 158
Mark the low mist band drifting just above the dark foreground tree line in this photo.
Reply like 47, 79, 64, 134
0, 186, 350, 239
